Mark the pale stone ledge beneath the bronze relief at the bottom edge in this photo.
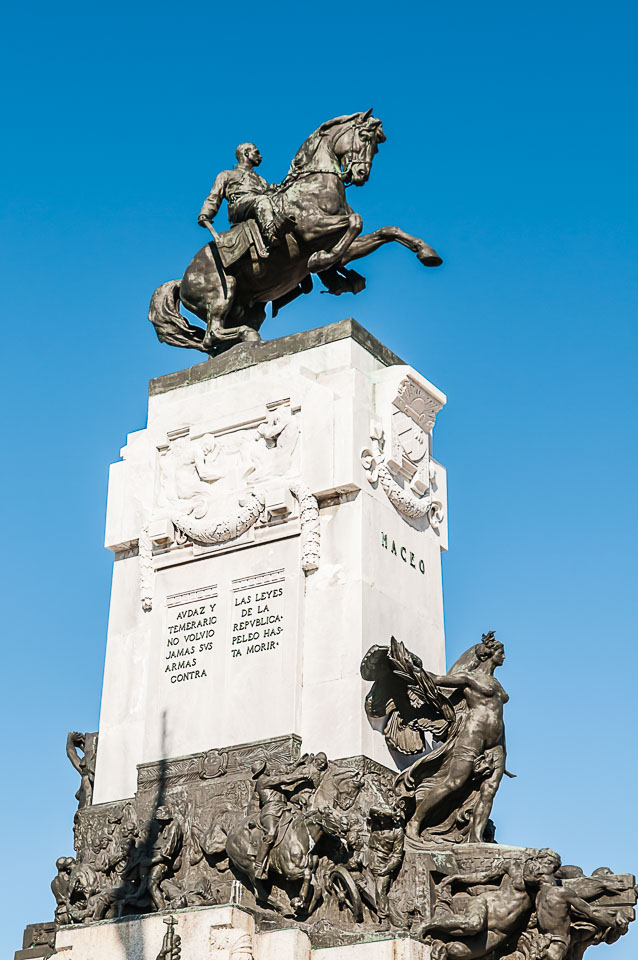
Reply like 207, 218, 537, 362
56, 904, 431, 960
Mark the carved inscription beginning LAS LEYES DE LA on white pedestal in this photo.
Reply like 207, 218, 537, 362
231, 570, 285, 659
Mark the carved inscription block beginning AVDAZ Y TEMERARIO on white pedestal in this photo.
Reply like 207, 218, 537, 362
162, 587, 219, 686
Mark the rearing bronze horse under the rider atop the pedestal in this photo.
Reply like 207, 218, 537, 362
149, 110, 442, 355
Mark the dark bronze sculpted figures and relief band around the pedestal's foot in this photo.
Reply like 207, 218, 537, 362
52, 632, 636, 960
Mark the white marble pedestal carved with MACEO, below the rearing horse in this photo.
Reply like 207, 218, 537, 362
94, 321, 447, 804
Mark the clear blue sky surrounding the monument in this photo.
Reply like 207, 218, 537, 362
0, 0, 638, 960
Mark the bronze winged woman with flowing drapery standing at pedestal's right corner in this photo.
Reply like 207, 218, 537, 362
368, 631, 511, 843
